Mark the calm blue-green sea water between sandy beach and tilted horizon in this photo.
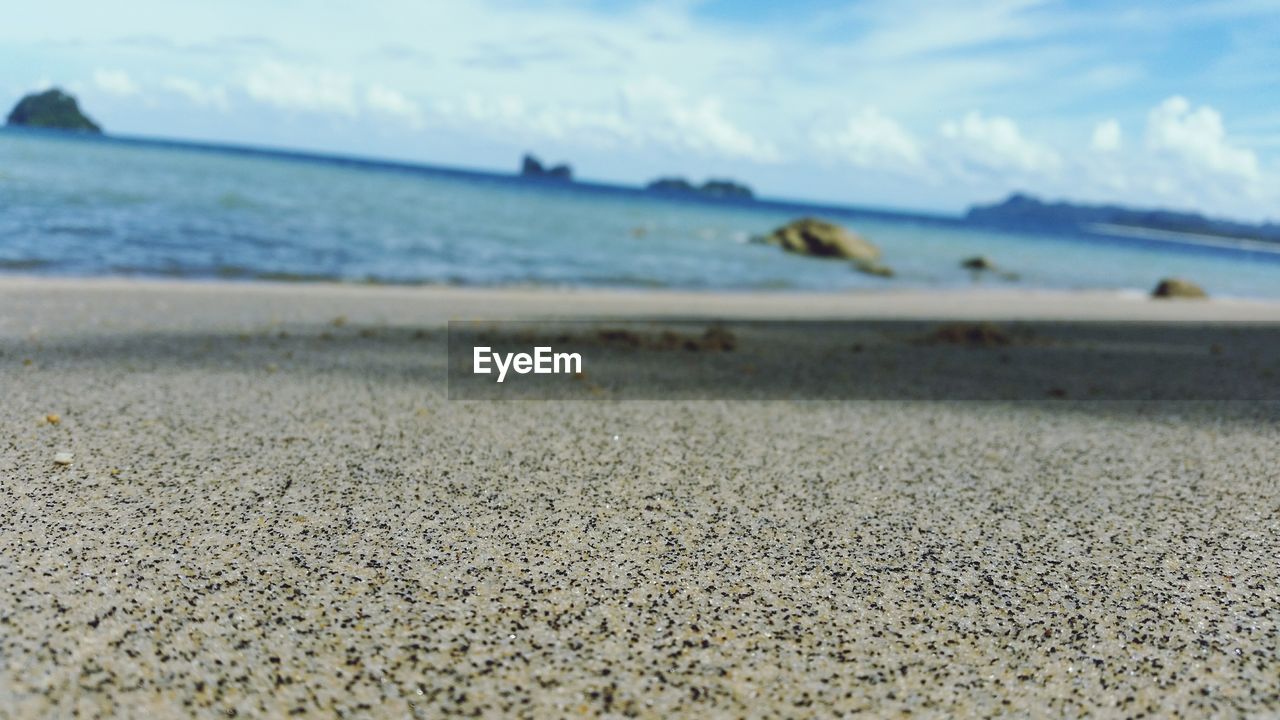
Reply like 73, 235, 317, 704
0, 131, 1280, 297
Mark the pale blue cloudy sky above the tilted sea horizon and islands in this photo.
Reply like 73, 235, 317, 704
0, 0, 1280, 222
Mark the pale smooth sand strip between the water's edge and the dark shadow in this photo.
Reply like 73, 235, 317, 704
0, 275, 1280, 323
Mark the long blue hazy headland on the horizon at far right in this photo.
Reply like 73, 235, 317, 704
966, 192, 1280, 242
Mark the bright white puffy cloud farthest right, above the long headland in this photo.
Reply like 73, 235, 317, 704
1147, 95, 1260, 179
